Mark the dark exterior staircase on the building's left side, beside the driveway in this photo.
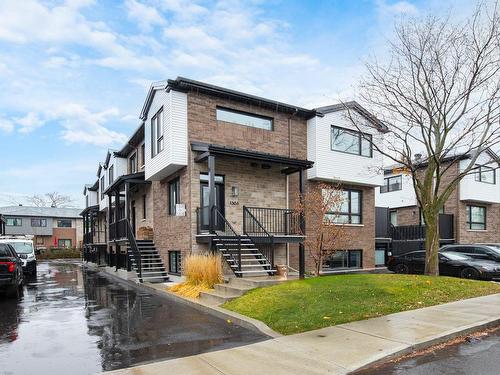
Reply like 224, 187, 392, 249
127, 240, 169, 283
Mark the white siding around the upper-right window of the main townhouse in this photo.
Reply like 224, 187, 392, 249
307, 111, 383, 186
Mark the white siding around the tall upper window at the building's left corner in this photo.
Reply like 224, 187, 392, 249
144, 90, 188, 180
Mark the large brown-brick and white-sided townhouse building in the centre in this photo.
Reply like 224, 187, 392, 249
82, 77, 386, 280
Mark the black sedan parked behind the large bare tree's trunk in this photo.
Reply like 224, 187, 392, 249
387, 251, 500, 280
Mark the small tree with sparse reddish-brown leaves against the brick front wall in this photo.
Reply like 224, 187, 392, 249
295, 183, 348, 276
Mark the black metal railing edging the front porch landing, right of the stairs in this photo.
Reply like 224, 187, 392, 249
243, 206, 301, 236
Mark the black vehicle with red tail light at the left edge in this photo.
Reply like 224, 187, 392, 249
0, 243, 24, 297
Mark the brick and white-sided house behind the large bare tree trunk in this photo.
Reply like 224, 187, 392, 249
375, 150, 500, 253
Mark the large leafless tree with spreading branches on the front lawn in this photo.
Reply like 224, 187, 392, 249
350, 3, 500, 275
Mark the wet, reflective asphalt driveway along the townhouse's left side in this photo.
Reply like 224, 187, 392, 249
0, 261, 266, 375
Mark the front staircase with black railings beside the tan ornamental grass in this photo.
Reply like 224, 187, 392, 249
212, 233, 276, 277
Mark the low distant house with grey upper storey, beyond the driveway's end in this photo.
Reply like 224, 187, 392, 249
0, 206, 83, 249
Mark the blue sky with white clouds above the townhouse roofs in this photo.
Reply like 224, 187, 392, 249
0, 0, 484, 207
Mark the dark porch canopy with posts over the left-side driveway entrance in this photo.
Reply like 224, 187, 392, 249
104, 172, 151, 241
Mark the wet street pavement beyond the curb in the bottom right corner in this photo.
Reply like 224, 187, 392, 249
356, 331, 500, 375
